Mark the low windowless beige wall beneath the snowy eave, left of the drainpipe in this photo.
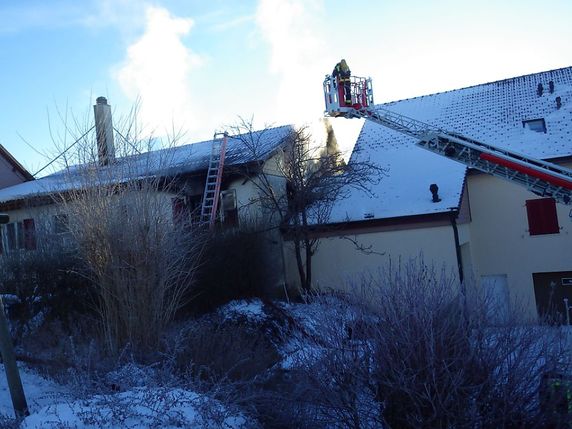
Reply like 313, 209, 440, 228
287, 222, 458, 289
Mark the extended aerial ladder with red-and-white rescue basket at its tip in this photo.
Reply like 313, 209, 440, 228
324, 75, 572, 205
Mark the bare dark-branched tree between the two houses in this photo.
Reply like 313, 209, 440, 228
231, 118, 385, 291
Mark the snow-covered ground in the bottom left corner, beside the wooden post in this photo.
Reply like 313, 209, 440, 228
0, 365, 248, 429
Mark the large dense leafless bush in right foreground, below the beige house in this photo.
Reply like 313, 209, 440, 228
362, 261, 568, 427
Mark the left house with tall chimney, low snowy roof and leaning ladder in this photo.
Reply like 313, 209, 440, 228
0, 97, 298, 258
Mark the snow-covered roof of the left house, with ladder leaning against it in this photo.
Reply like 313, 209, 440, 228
0, 125, 292, 203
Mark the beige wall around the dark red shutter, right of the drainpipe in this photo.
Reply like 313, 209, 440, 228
467, 169, 572, 316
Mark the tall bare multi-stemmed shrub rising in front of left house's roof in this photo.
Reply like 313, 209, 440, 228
48, 104, 204, 353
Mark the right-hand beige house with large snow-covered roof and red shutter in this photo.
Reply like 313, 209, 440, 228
300, 67, 572, 317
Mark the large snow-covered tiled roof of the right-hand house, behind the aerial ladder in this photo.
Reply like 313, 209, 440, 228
330, 67, 572, 223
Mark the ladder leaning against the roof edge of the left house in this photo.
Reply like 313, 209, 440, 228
200, 132, 228, 229
